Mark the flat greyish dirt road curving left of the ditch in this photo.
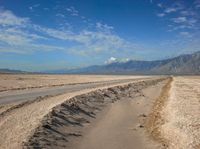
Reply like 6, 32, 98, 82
0, 77, 148, 104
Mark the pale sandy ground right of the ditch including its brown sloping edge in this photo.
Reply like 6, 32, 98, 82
145, 76, 200, 149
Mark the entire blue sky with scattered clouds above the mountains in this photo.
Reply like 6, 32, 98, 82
0, 0, 200, 71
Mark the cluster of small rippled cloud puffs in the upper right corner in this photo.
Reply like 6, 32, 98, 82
156, 0, 199, 34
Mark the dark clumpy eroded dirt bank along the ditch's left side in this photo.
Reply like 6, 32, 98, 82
24, 78, 166, 148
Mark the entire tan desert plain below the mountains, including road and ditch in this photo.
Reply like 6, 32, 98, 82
0, 74, 200, 149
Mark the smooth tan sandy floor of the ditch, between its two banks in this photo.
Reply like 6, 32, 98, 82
72, 79, 167, 149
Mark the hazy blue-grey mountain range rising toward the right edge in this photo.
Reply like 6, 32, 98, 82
67, 52, 200, 74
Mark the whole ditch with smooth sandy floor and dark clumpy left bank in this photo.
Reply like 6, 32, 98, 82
25, 79, 165, 149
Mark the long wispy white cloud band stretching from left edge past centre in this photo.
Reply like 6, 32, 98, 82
0, 10, 135, 56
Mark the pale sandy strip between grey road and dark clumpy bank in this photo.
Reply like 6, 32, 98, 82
0, 77, 161, 149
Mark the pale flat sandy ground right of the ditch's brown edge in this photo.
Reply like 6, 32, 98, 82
161, 77, 200, 149
